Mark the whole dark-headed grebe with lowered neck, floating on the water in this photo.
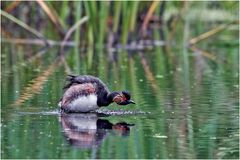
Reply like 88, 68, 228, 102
58, 75, 135, 113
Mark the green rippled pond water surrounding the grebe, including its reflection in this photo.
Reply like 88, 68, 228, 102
1, 43, 239, 158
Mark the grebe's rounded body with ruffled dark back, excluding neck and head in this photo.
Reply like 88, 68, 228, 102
60, 75, 109, 112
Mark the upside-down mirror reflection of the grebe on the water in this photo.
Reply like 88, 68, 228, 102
60, 113, 134, 148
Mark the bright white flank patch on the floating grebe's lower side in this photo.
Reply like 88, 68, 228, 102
68, 94, 98, 112
